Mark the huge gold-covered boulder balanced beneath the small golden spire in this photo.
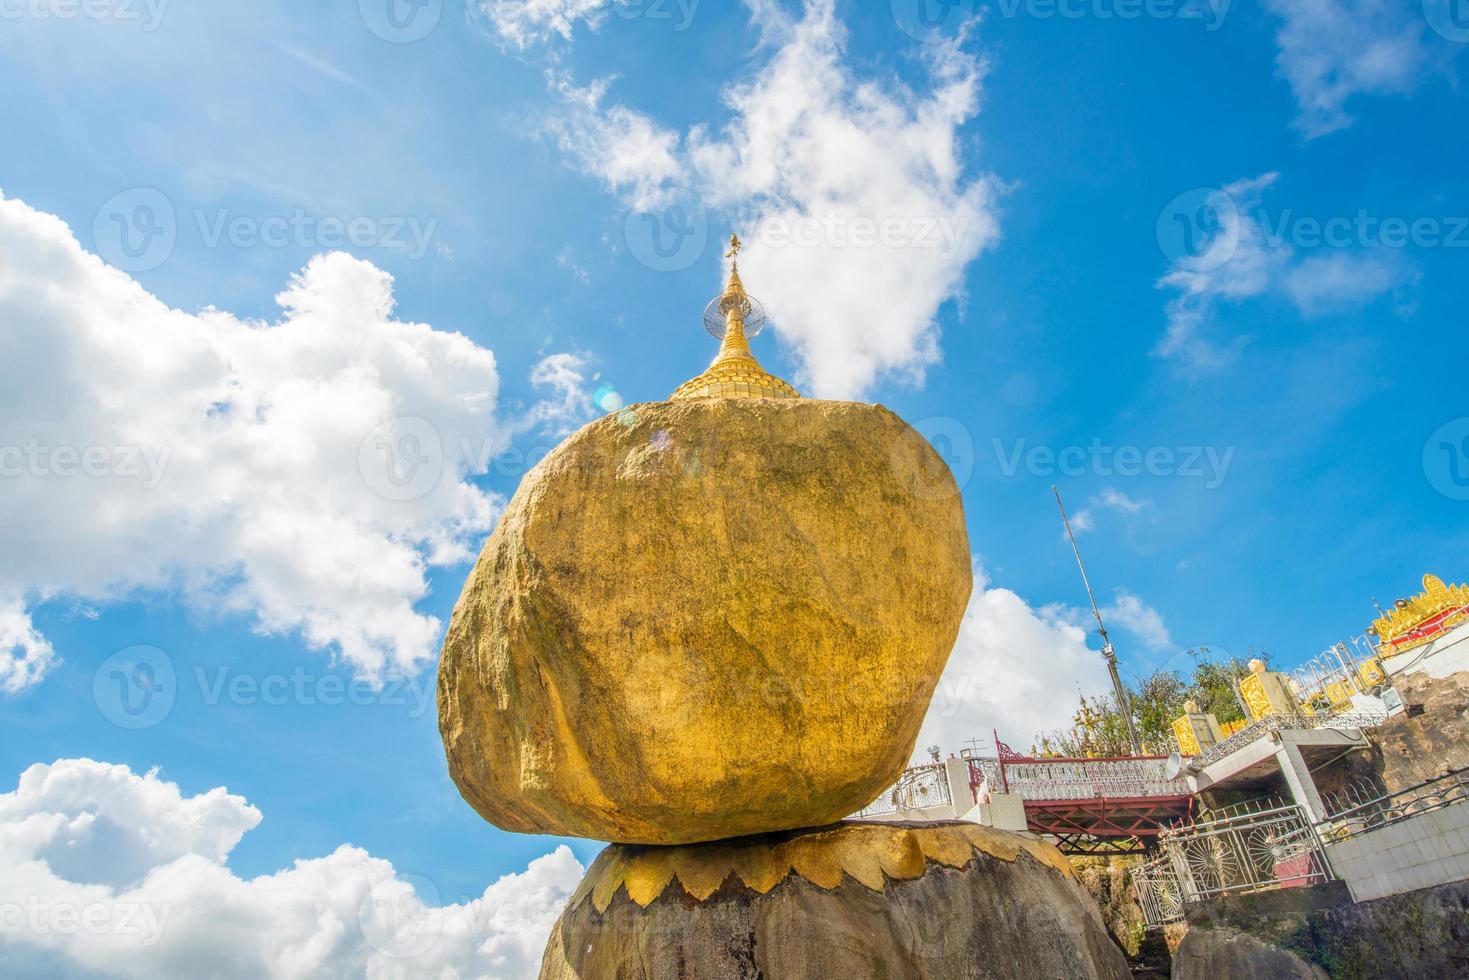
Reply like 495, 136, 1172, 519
438, 397, 972, 843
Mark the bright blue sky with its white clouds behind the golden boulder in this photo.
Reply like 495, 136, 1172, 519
0, 0, 1469, 976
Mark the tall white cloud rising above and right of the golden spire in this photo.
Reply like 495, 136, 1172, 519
540, 0, 1000, 398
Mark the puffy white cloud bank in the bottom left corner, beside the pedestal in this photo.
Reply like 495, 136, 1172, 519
0, 760, 582, 980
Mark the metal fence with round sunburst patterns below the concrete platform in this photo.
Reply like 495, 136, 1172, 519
1131, 801, 1332, 927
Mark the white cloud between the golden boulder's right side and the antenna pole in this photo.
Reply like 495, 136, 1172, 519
915, 567, 1111, 761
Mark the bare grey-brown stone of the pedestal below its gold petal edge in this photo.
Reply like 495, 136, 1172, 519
541, 854, 1130, 980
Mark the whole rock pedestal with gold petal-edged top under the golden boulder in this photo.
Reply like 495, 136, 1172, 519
541, 823, 1128, 980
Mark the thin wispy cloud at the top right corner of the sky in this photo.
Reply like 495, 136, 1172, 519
1265, 0, 1428, 140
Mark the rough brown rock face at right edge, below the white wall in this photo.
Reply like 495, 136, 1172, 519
1372, 673, 1469, 790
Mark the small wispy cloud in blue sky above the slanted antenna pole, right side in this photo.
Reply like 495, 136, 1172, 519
1155, 172, 1416, 370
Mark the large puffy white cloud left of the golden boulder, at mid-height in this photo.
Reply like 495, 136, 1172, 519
0, 198, 549, 689
